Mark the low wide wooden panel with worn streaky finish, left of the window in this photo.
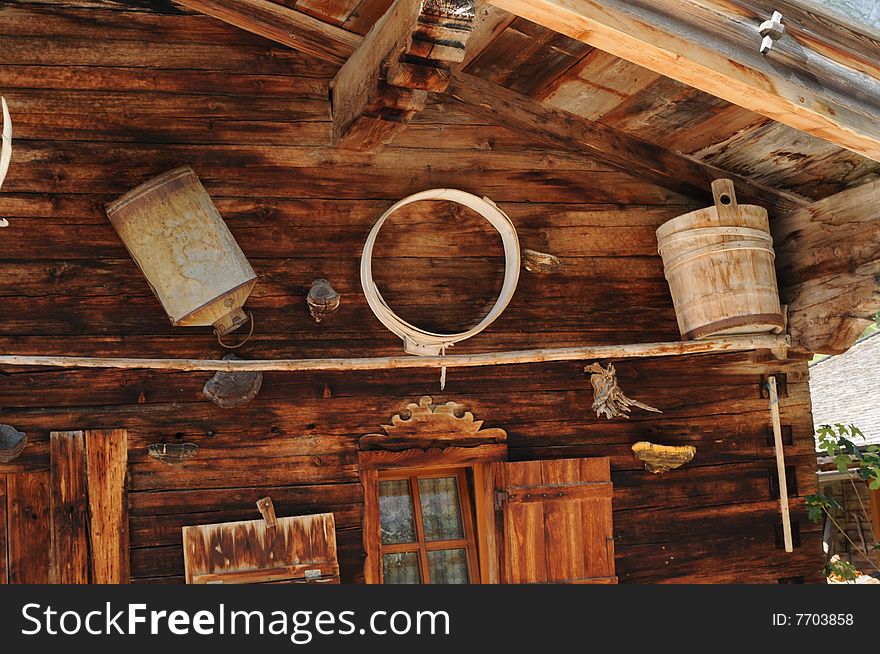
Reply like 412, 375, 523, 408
183, 513, 339, 584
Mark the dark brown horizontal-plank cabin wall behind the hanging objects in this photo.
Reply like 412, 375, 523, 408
0, 1, 822, 582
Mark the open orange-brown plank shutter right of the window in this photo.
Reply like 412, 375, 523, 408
493, 458, 617, 584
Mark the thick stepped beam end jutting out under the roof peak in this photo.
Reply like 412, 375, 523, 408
330, 0, 475, 151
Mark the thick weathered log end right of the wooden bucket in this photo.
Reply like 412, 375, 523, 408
771, 180, 880, 354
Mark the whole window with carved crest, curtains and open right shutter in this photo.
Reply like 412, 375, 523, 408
358, 396, 617, 584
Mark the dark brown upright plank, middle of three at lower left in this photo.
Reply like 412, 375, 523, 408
49, 431, 90, 584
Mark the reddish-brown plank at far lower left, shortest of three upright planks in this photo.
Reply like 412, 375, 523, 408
6, 470, 52, 584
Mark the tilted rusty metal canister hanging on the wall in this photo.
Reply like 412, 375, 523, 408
107, 166, 257, 337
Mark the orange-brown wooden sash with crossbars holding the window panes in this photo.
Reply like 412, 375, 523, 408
377, 467, 480, 584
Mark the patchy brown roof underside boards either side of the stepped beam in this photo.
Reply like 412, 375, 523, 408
208, 0, 880, 205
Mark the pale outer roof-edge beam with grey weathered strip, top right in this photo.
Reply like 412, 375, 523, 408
489, 0, 880, 161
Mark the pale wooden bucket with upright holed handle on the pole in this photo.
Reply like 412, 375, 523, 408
657, 179, 785, 339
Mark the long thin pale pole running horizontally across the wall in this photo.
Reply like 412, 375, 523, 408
0, 335, 789, 372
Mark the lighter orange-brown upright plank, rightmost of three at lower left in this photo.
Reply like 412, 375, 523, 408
85, 429, 130, 584
